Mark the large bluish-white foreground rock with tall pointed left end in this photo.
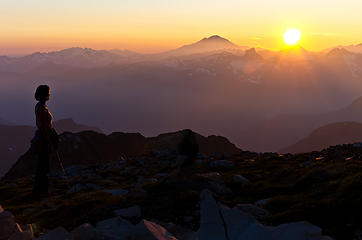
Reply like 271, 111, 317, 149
199, 190, 331, 240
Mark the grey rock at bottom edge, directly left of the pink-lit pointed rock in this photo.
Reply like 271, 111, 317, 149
96, 217, 134, 240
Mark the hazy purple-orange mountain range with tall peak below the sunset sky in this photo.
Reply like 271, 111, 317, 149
0, 35, 362, 151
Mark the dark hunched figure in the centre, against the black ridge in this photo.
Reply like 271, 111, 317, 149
178, 129, 199, 174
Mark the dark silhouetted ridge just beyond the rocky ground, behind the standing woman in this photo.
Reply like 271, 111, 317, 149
3, 131, 241, 179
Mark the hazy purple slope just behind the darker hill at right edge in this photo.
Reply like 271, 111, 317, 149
232, 94, 362, 151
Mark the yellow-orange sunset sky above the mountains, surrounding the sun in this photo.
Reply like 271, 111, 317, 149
0, 0, 362, 55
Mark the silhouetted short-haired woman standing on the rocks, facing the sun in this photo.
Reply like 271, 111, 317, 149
33, 85, 53, 197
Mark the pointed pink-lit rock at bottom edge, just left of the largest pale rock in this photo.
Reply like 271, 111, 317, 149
131, 220, 177, 240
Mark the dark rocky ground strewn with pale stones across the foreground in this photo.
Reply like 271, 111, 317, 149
0, 145, 362, 240
